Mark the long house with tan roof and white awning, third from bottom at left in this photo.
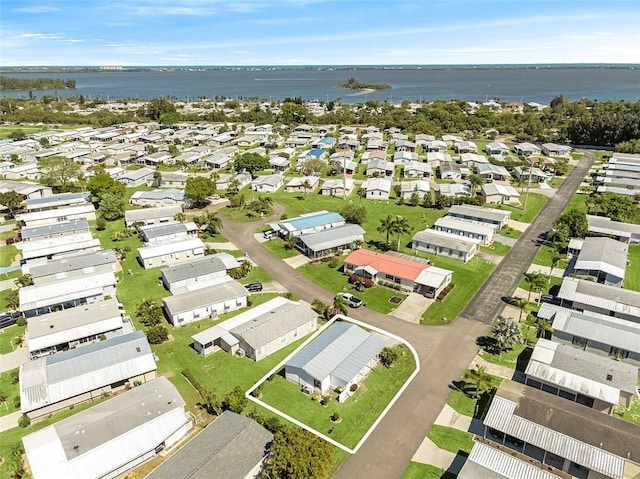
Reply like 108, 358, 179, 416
27, 299, 127, 358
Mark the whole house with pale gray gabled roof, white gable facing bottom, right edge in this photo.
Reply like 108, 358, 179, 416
573, 237, 638, 287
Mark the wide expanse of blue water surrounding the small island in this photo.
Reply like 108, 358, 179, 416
2, 65, 640, 104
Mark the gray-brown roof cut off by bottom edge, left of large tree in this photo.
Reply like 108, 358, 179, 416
147, 411, 273, 479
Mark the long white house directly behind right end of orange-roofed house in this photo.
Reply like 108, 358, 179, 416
411, 225, 481, 263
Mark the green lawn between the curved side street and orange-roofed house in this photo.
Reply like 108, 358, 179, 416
296, 259, 407, 314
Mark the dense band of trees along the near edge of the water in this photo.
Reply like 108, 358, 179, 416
5, 96, 640, 146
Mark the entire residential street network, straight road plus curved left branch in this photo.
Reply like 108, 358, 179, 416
216, 153, 595, 479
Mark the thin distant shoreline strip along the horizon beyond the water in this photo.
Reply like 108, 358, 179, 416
0, 63, 640, 75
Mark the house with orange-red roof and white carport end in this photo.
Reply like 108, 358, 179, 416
344, 249, 453, 298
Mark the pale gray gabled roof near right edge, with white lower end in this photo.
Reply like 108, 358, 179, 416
574, 236, 629, 278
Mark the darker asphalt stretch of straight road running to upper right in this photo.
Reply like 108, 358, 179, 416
461, 152, 596, 324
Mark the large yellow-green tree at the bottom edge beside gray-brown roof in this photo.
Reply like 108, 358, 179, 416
264, 426, 333, 479
